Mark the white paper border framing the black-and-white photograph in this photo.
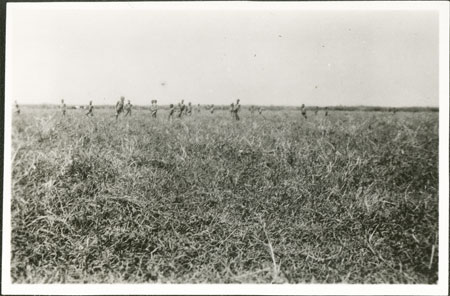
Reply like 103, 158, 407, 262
1, 1, 449, 295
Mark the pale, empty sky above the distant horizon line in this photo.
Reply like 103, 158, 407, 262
6, 3, 439, 107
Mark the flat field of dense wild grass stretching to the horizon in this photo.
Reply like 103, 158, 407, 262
11, 107, 439, 283
